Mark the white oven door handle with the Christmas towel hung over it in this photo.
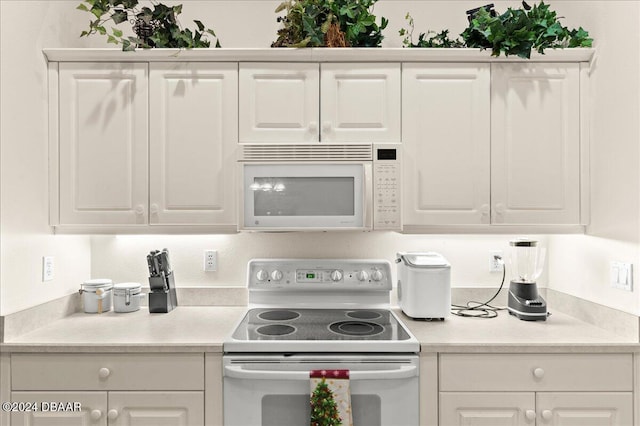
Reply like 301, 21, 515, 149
224, 365, 418, 380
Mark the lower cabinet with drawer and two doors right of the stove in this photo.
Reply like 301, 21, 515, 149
439, 354, 634, 426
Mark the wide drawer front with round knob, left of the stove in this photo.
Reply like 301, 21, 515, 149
11, 354, 204, 390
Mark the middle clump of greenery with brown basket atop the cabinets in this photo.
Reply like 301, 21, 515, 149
271, 0, 389, 47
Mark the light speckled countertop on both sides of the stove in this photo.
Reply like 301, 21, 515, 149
0, 307, 640, 353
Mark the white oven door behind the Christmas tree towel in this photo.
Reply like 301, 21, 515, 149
223, 355, 419, 426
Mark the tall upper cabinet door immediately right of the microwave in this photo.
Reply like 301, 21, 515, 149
402, 64, 490, 225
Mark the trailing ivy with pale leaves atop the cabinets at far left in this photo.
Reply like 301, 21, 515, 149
77, 0, 220, 51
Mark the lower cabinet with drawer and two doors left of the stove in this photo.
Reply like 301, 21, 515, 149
11, 354, 205, 426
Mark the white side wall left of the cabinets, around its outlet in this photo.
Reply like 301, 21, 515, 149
0, 0, 91, 315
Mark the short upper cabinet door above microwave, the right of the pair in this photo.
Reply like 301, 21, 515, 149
320, 63, 400, 142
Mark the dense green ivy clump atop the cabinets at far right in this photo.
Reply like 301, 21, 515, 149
461, 1, 593, 58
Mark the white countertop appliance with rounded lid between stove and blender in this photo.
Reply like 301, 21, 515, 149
396, 252, 451, 319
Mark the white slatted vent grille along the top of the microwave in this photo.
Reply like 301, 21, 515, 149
240, 144, 373, 161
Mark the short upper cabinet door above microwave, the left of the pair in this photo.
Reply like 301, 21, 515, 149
239, 63, 320, 143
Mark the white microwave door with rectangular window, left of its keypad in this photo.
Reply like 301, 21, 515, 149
239, 162, 373, 231
